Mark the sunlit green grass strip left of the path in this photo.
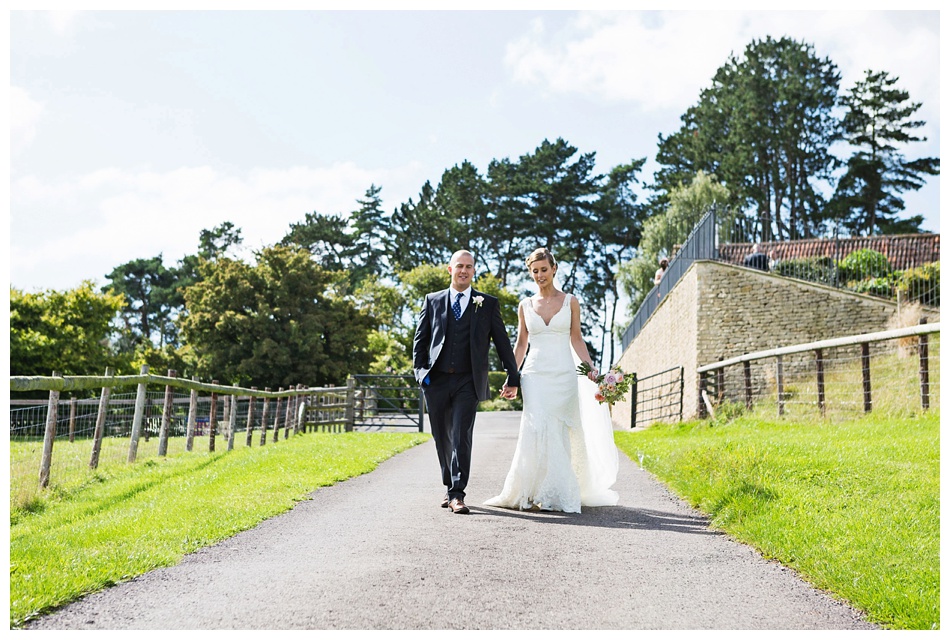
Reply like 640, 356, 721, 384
10, 433, 429, 626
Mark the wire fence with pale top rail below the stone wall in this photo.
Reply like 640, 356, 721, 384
697, 324, 940, 420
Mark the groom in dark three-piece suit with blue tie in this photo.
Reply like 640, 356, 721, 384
412, 250, 520, 513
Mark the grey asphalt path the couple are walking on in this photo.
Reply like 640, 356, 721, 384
28, 412, 875, 630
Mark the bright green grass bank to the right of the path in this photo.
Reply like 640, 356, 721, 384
617, 413, 940, 629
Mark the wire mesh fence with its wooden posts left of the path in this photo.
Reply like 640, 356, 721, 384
9, 368, 355, 505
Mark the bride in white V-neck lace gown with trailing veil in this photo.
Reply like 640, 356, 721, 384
485, 249, 619, 513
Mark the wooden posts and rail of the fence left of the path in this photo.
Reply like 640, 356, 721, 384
10, 365, 384, 487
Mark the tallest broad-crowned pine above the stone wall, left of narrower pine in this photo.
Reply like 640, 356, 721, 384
655, 37, 840, 240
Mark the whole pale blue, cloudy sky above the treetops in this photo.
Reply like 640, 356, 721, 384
9, 3, 940, 291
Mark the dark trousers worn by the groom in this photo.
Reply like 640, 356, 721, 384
422, 371, 478, 500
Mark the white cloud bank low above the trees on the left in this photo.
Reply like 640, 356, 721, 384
10, 163, 421, 290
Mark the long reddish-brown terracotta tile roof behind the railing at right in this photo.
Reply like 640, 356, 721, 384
719, 233, 940, 270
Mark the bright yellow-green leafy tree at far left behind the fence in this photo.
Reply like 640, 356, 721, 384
10, 281, 129, 376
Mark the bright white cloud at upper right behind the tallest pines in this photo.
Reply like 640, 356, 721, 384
505, 11, 939, 120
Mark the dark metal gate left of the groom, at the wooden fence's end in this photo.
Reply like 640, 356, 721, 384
353, 374, 425, 432
